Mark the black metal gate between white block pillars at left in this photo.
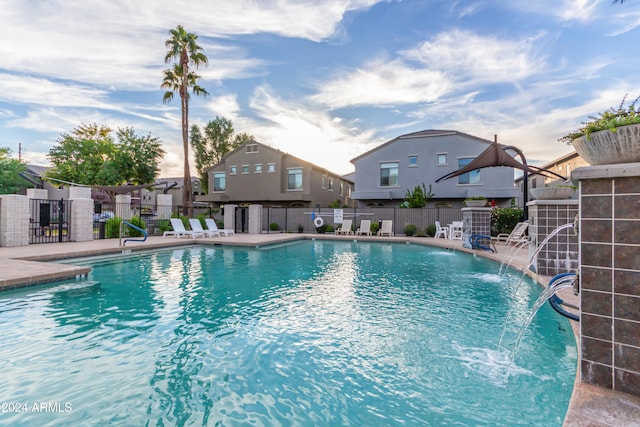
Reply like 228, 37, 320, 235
29, 199, 71, 244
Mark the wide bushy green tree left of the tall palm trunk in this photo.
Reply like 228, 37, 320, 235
46, 124, 165, 185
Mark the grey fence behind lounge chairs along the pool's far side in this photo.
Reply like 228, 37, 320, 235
262, 207, 462, 234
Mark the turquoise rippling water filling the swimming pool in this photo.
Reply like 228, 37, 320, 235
0, 241, 577, 426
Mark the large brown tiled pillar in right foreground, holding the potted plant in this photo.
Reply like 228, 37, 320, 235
572, 163, 640, 396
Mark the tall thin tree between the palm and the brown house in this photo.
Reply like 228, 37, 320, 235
191, 116, 254, 192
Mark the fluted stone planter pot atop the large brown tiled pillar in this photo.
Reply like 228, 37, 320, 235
572, 125, 640, 166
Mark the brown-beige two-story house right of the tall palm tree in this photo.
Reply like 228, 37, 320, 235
197, 141, 353, 207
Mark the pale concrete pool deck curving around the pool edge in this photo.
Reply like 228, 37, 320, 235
0, 233, 640, 427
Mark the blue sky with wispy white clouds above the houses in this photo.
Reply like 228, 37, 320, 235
0, 0, 640, 177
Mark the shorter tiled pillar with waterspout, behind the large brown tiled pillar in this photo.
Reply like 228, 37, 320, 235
527, 200, 578, 276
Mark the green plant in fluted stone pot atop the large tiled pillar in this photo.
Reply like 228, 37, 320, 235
559, 95, 640, 166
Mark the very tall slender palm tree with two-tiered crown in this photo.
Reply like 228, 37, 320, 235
160, 25, 209, 217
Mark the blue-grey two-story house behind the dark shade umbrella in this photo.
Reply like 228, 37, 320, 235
351, 130, 518, 207
